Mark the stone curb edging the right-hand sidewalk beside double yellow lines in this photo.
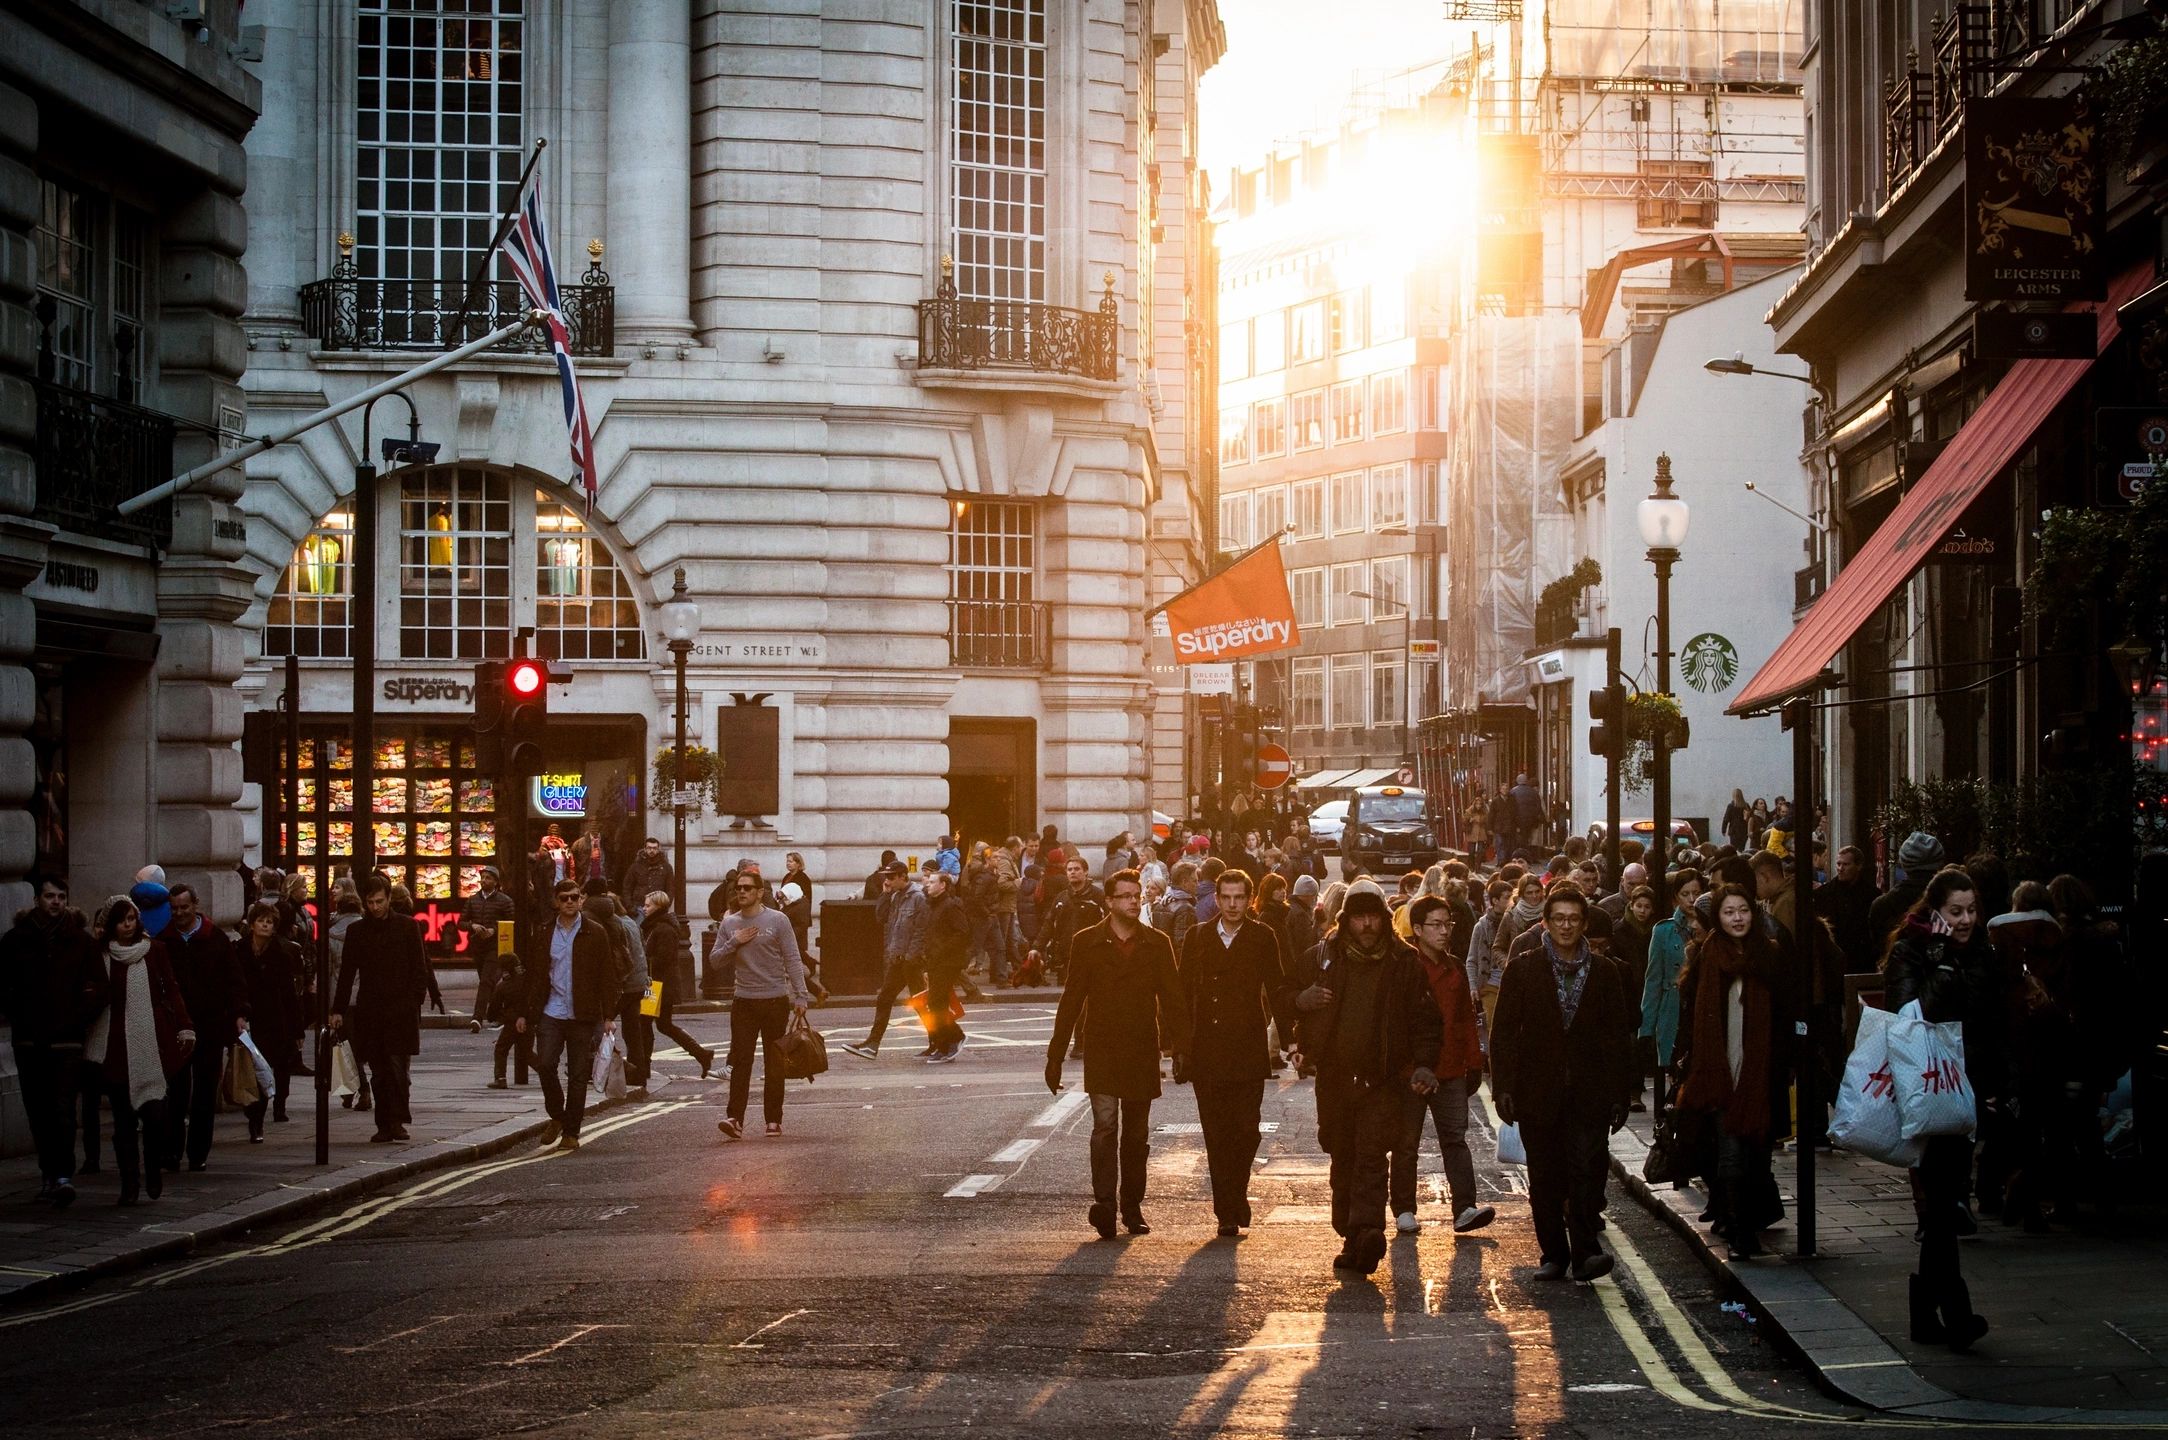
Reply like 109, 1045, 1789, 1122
1611, 1130, 2168, 1429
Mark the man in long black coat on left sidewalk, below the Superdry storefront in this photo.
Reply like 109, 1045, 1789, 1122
332, 874, 431, 1145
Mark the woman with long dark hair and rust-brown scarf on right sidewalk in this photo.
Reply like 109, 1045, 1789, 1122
1678, 885, 1784, 1258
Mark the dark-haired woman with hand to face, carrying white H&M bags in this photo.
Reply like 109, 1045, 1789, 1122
1882, 867, 2012, 1349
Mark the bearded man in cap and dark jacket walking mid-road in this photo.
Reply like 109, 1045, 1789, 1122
1294, 880, 1446, 1275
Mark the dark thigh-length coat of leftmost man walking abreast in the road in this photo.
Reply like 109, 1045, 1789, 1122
1047, 924, 1188, 1100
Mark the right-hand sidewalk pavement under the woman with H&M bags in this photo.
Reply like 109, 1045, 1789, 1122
1611, 1115, 2168, 1427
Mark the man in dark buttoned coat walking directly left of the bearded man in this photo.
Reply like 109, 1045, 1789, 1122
1175, 870, 1294, 1238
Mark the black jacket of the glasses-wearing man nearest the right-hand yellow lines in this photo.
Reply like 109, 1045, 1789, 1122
1492, 948, 1635, 1126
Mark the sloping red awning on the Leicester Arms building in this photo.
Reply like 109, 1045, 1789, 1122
1726, 260, 2153, 716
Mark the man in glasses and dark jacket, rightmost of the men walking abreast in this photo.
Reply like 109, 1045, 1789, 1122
1492, 883, 1633, 1280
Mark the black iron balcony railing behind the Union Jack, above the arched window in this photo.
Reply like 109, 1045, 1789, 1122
301, 245, 618, 356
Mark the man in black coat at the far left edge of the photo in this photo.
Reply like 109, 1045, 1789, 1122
0, 876, 108, 1206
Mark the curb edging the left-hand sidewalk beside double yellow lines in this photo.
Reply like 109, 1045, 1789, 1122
0, 1076, 676, 1310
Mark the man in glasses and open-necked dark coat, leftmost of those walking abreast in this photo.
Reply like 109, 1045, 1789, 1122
1047, 870, 1188, 1240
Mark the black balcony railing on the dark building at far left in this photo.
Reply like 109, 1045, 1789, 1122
33, 380, 173, 549
